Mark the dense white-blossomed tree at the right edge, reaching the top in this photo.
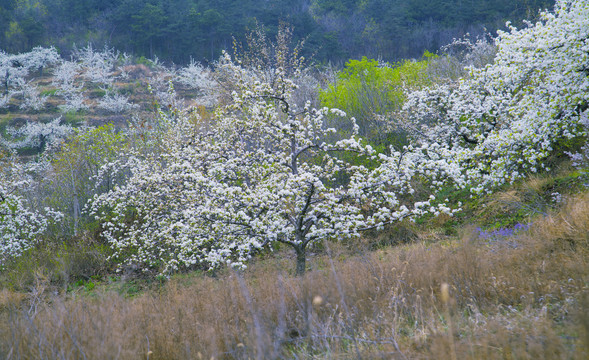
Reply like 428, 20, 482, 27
401, 0, 589, 192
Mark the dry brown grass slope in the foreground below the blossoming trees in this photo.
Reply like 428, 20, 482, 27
0, 194, 589, 359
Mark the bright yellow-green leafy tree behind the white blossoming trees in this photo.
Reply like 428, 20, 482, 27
319, 53, 433, 136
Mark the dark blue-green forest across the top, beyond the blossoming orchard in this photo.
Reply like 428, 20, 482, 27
0, 0, 554, 63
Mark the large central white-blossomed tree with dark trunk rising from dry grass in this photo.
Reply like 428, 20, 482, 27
91, 56, 454, 274
